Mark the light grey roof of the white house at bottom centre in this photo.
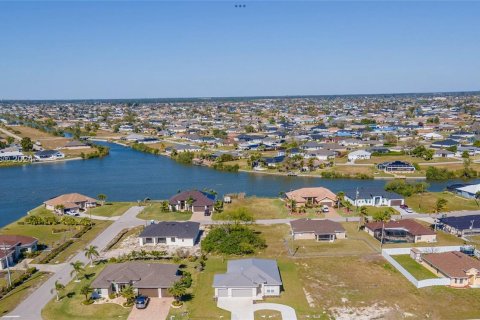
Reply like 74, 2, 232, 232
213, 258, 282, 288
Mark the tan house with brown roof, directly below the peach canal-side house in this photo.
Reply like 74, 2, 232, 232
290, 219, 346, 242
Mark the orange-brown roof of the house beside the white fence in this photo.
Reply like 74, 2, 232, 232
422, 251, 480, 278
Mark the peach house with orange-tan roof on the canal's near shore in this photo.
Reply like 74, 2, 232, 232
285, 187, 337, 207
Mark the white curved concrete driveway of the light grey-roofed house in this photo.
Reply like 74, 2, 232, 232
217, 298, 297, 320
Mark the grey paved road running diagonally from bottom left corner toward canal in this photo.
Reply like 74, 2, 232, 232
3, 206, 145, 320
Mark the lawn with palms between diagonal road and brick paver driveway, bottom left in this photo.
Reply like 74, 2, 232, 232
42, 264, 131, 320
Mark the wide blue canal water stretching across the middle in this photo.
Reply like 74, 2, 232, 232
0, 144, 474, 226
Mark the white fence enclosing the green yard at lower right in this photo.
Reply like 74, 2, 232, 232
382, 246, 460, 288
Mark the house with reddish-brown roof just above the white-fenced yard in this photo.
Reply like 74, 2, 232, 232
365, 219, 437, 243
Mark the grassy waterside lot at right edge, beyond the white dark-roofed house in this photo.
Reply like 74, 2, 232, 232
405, 191, 480, 213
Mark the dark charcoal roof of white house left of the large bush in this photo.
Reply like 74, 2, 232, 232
139, 221, 200, 239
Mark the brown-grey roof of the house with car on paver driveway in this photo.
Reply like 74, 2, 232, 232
91, 262, 180, 288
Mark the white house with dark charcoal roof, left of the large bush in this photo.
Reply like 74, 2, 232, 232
138, 221, 200, 247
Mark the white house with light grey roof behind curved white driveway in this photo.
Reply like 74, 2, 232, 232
213, 258, 282, 300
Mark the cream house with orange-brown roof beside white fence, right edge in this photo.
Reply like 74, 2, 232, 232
421, 251, 480, 288
